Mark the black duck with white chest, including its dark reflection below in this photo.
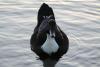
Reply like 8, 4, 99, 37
30, 3, 69, 67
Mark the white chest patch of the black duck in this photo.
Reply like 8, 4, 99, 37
41, 34, 59, 55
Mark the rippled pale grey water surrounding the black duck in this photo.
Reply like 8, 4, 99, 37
0, 0, 100, 67
